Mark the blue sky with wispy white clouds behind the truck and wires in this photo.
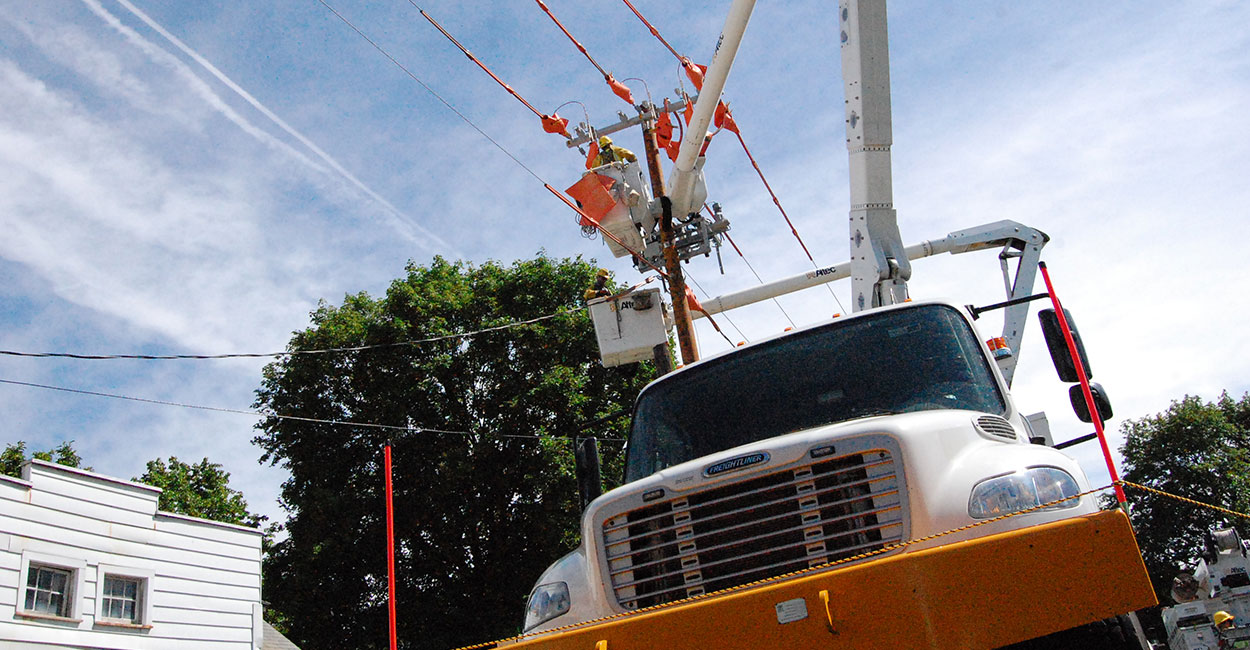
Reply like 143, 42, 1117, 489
0, 0, 1250, 516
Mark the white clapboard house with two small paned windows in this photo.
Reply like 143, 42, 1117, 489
0, 460, 264, 650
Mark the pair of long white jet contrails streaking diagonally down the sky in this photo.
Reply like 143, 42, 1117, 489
83, 0, 461, 258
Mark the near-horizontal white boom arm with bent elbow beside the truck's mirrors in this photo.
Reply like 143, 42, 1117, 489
694, 220, 1050, 384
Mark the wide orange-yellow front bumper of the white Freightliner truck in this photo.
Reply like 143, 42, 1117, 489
509, 510, 1156, 650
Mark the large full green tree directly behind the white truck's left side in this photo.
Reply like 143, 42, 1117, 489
256, 255, 653, 650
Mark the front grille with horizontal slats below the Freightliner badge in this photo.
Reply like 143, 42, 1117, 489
603, 449, 906, 609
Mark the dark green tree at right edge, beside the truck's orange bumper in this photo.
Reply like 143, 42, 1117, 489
1120, 393, 1250, 603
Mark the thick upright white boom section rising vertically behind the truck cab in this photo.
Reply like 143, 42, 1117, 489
838, 0, 911, 311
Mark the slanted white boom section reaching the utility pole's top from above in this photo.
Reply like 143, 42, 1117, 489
669, 0, 755, 219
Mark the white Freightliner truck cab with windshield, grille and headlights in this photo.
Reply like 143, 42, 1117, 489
524, 301, 1098, 633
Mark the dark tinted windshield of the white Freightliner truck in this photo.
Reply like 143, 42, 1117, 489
625, 305, 1006, 481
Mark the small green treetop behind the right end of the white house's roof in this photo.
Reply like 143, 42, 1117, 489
134, 456, 266, 528
